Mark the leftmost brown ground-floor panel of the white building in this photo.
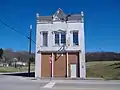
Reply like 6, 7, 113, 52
41, 53, 51, 77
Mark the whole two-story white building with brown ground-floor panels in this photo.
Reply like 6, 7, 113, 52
35, 9, 86, 78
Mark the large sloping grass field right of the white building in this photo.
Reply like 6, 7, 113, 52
86, 61, 120, 79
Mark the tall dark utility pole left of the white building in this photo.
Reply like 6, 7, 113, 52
28, 25, 32, 77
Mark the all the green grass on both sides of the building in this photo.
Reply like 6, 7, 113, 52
0, 61, 120, 79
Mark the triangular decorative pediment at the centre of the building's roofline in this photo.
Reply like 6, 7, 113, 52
53, 8, 66, 21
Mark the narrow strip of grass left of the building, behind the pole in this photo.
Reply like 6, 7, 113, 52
0, 65, 34, 73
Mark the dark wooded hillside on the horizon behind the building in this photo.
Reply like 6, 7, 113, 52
3, 49, 120, 62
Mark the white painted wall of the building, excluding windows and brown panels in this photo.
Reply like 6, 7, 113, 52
35, 9, 86, 78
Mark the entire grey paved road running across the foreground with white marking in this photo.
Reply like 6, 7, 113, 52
0, 75, 120, 90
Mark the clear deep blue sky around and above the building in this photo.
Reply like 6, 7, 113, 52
0, 0, 120, 52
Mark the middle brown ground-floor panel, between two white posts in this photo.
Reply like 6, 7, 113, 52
54, 54, 66, 77
